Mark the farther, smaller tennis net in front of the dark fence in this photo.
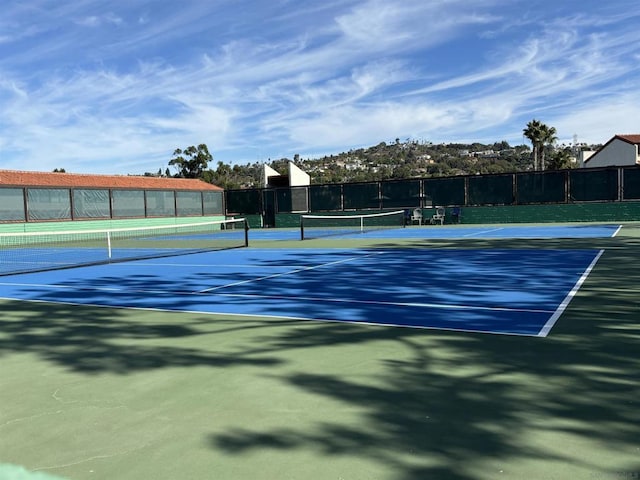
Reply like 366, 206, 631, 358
300, 210, 405, 240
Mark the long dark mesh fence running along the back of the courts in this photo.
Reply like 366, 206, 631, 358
225, 166, 640, 217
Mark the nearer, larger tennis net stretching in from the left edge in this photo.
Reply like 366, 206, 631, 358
0, 218, 249, 275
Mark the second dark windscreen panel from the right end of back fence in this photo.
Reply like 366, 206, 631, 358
569, 168, 618, 202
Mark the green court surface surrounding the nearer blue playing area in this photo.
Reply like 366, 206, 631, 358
0, 227, 640, 480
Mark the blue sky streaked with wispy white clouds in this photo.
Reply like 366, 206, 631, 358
0, 0, 640, 174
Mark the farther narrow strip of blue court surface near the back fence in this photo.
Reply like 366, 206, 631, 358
249, 224, 622, 240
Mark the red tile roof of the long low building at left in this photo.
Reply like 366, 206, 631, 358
0, 170, 222, 191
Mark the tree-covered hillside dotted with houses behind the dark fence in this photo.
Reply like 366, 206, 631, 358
146, 139, 594, 189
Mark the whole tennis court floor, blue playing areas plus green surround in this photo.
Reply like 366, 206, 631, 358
0, 220, 640, 480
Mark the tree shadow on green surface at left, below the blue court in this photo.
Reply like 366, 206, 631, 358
0, 301, 292, 374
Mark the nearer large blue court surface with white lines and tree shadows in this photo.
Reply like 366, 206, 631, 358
0, 248, 602, 336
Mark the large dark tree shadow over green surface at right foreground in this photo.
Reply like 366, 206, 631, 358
210, 236, 640, 480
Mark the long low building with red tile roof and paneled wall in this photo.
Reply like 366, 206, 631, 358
0, 170, 224, 223
